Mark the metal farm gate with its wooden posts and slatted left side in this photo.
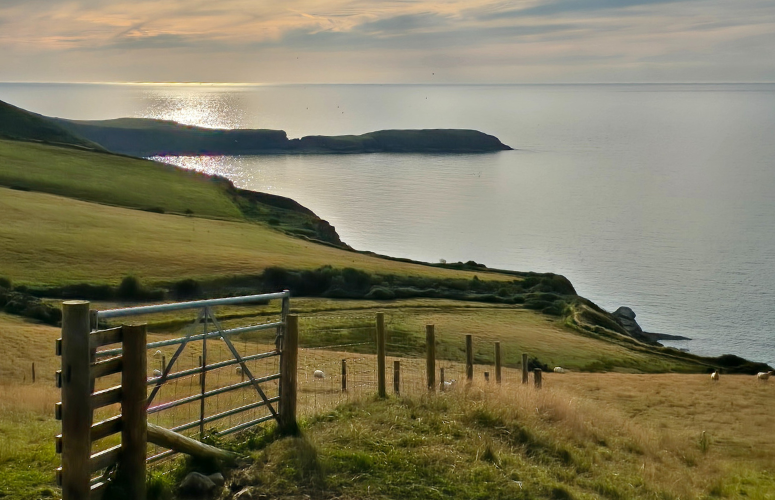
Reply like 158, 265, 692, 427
56, 290, 298, 500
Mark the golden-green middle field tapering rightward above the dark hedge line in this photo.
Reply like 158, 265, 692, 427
0, 188, 513, 285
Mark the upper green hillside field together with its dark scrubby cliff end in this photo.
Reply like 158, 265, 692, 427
0, 139, 352, 246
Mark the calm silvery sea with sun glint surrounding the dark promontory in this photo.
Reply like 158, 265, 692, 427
0, 84, 775, 364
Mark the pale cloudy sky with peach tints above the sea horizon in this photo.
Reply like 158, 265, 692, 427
0, 0, 775, 83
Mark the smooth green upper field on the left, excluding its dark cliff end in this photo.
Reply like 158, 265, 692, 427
0, 140, 242, 219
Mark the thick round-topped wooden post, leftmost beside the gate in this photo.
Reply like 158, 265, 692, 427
61, 301, 92, 500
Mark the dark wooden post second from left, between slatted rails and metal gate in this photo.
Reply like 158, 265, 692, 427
118, 324, 148, 500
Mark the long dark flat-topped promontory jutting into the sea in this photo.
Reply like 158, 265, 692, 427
55, 118, 512, 157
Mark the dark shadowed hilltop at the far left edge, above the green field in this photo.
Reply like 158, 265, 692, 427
0, 101, 102, 150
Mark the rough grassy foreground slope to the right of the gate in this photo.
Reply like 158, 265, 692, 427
214, 374, 775, 500
